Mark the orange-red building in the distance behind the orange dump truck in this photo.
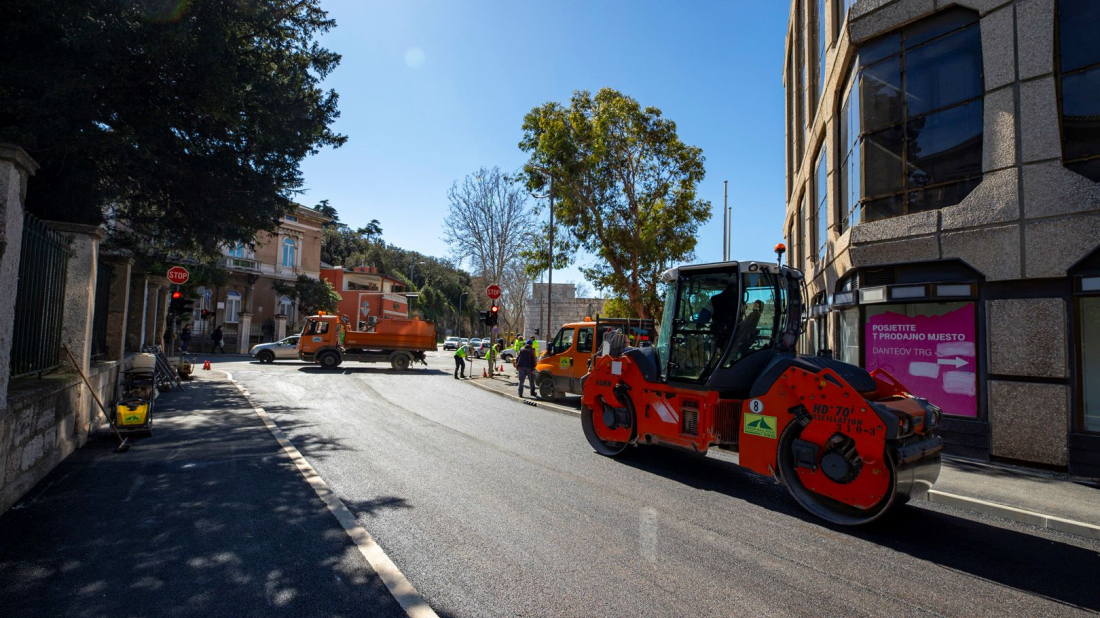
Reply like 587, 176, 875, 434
321, 266, 409, 330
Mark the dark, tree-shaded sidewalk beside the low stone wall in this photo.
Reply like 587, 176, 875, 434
0, 372, 406, 618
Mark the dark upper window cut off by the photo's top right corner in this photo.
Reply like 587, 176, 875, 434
1058, 0, 1100, 181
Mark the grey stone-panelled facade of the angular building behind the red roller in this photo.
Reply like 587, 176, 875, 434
783, 0, 1100, 475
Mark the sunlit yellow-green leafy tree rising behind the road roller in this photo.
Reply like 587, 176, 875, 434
519, 88, 711, 318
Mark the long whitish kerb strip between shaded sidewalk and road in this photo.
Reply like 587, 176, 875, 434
219, 369, 439, 618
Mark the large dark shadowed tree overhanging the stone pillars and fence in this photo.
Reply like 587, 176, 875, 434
0, 0, 345, 253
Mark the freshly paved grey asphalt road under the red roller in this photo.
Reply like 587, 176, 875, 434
216, 353, 1100, 617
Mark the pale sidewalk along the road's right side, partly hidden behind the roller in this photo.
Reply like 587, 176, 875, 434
462, 365, 1100, 539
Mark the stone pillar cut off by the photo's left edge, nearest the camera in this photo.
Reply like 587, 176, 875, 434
0, 144, 39, 413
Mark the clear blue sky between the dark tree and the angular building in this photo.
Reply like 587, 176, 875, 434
299, 0, 788, 292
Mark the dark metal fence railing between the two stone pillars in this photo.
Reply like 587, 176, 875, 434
11, 212, 72, 378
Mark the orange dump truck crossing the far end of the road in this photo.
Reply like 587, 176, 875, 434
298, 313, 436, 371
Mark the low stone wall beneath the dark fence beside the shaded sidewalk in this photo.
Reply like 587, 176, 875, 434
0, 360, 130, 514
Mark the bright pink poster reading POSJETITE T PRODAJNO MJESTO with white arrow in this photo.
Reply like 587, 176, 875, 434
865, 304, 978, 418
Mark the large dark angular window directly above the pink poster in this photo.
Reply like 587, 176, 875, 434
838, 9, 983, 224
